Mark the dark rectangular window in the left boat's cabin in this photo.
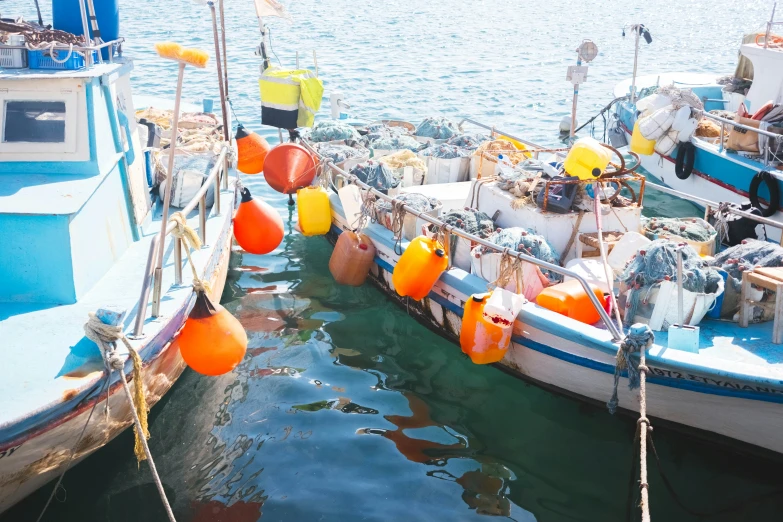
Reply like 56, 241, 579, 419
3, 100, 65, 143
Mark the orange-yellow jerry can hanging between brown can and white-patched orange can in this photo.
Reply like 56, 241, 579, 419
392, 236, 449, 301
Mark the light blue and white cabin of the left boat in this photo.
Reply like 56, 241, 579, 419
0, 58, 150, 305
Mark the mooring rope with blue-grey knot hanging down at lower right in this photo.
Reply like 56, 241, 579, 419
606, 323, 655, 522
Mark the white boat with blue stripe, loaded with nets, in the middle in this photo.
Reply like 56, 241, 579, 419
288, 119, 783, 453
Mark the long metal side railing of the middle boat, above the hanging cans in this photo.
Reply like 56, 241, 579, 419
302, 138, 623, 342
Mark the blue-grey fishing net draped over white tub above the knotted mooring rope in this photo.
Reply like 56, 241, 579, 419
620, 239, 723, 323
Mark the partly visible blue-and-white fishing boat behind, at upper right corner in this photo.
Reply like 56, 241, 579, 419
611, 9, 783, 234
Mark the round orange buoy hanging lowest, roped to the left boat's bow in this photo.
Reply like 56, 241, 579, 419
175, 290, 247, 375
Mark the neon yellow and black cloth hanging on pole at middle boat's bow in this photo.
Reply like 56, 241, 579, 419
258, 67, 324, 129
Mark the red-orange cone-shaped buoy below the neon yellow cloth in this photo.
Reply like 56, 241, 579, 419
264, 143, 317, 194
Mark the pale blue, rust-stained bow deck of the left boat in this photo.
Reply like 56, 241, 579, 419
0, 184, 234, 441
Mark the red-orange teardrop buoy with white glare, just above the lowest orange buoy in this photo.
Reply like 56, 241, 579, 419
234, 187, 284, 254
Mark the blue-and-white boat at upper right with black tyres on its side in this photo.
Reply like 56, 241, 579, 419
613, 9, 783, 241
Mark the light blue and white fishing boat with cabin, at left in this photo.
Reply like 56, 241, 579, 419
0, 1, 238, 511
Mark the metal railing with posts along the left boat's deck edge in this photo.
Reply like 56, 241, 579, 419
133, 143, 229, 338
